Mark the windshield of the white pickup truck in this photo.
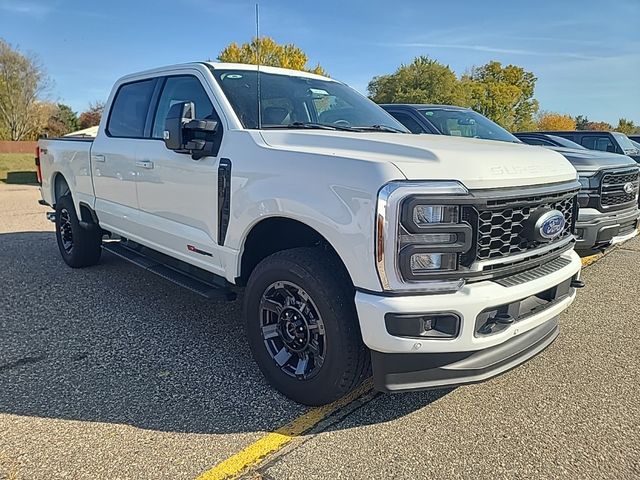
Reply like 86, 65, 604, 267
212, 69, 407, 133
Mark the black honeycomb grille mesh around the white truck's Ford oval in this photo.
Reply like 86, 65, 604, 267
476, 197, 576, 260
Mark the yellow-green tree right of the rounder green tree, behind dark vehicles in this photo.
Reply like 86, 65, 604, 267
462, 62, 538, 131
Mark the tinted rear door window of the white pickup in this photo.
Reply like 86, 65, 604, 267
107, 78, 156, 138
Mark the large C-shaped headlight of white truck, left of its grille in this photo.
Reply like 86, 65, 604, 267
376, 182, 472, 291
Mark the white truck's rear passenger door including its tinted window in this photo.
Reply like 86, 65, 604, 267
91, 79, 156, 233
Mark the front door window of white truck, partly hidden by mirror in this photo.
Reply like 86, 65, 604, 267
152, 75, 220, 138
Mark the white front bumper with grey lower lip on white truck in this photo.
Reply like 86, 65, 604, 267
356, 251, 581, 391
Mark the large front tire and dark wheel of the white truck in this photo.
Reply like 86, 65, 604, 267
244, 248, 370, 405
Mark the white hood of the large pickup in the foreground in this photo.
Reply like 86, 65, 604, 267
260, 130, 576, 189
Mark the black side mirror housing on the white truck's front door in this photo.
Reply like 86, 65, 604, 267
162, 102, 218, 160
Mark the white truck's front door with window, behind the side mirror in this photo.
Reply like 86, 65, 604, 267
137, 70, 223, 273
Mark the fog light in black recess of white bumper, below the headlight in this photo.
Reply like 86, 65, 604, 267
384, 313, 460, 338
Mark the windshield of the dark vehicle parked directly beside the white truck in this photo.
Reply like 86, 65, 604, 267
420, 108, 522, 143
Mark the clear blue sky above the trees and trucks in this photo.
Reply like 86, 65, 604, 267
0, 0, 640, 124
